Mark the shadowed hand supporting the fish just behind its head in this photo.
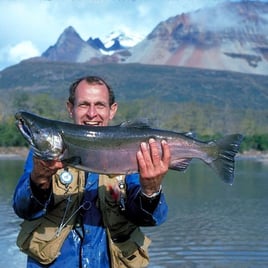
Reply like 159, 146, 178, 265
31, 157, 64, 190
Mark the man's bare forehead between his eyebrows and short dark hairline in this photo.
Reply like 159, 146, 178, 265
75, 80, 109, 101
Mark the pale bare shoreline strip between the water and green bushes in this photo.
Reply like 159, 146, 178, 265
0, 147, 268, 162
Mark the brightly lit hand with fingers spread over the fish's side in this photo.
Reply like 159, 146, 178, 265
137, 139, 171, 196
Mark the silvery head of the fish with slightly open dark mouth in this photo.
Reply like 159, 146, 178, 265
15, 112, 64, 160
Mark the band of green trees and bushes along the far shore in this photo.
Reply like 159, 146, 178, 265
0, 95, 268, 151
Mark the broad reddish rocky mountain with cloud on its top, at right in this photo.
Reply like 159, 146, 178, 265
126, 2, 268, 74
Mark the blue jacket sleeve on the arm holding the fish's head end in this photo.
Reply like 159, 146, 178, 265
13, 151, 51, 220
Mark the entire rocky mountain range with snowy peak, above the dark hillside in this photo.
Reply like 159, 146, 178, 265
37, 1, 268, 75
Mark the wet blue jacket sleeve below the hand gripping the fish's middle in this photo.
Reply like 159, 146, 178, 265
123, 174, 168, 226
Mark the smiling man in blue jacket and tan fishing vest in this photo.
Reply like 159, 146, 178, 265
13, 76, 170, 268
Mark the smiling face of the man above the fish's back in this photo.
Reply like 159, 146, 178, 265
67, 80, 117, 126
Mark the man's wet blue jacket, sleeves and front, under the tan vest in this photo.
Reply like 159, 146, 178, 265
13, 151, 167, 268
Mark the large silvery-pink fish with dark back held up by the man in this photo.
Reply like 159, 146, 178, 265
15, 111, 242, 184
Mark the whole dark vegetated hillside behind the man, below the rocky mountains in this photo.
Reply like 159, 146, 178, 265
0, 62, 268, 151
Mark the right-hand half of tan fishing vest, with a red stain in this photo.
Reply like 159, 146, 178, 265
99, 175, 151, 268
